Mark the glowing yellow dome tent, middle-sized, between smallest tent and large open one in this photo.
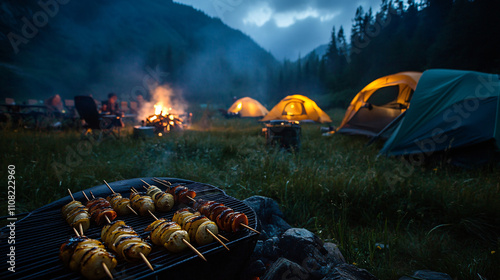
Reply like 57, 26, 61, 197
261, 94, 332, 123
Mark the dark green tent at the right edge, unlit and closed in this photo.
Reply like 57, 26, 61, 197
380, 69, 500, 160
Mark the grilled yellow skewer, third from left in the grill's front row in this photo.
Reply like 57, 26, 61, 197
144, 212, 207, 261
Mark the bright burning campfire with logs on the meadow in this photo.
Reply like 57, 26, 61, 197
145, 103, 183, 136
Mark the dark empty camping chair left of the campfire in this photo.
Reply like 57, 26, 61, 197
75, 96, 121, 140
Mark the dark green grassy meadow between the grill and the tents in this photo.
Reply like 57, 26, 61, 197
0, 110, 500, 279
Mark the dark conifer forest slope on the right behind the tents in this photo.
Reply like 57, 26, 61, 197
271, 0, 500, 108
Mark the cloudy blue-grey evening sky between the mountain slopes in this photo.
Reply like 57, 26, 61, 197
174, 0, 381, 60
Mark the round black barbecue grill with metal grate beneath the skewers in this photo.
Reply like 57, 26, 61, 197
0, 178, 258, 279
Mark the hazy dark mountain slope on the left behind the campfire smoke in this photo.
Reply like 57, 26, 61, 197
0, 0, 279, 102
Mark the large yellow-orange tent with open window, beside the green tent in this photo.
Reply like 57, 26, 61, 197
337, 72, 422, 136
